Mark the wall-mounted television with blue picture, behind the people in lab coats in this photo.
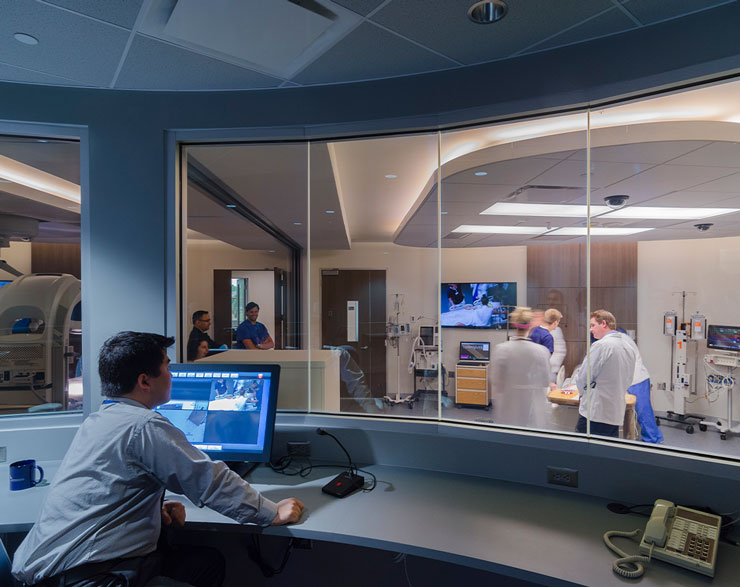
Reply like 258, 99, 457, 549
441, 282, 516, 329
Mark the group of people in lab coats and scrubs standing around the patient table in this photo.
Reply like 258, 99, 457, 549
491, 307, 663, 443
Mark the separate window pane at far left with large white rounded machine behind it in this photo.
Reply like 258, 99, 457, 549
0, 136, 82, 414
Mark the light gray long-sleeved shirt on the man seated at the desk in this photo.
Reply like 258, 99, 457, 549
13, 398, 277, 583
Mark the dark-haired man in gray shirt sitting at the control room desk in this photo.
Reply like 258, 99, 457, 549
13, 332, 303, 587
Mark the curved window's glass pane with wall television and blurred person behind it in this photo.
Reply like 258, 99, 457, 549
440, 114, 587, 432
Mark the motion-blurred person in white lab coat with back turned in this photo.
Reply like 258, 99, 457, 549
491, 307, 550, 428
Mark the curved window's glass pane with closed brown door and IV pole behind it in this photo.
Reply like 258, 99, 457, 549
310, 135, 445, 418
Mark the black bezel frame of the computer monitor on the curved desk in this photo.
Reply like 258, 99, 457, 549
168, 362, 280, 463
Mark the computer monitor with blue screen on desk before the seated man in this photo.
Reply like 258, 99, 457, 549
157, 363, 280, 463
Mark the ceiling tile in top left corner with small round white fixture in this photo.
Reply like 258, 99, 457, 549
0, 2, 129, 86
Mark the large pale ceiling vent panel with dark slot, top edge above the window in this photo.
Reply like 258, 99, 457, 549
142, 0, 361, 79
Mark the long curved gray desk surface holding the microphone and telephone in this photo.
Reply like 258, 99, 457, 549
0, 463, 740, 587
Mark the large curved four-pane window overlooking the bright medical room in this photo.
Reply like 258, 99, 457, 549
178, 76, 740, 457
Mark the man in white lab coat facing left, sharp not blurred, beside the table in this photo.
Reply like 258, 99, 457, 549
576, 310, 637, 437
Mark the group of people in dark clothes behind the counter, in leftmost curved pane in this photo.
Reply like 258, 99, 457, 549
187, 302, 275, 363
